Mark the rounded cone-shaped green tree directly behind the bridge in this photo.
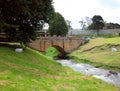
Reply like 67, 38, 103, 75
49, 13, 68, 36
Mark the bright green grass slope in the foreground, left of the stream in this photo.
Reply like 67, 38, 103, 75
0, 45, 120, 91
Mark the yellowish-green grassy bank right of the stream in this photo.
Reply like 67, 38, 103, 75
71, 37, 120, 71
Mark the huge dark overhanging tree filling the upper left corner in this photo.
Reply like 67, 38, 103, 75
0, 0, 54, 45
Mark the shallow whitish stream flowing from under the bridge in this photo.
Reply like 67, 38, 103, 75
57, 60, 120, 87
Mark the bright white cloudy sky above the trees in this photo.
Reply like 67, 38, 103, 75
53, 0, 120, 28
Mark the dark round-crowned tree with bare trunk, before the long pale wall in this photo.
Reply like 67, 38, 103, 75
90, 15, 104, 35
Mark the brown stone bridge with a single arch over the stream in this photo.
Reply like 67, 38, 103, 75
29, 37, 87, 53
